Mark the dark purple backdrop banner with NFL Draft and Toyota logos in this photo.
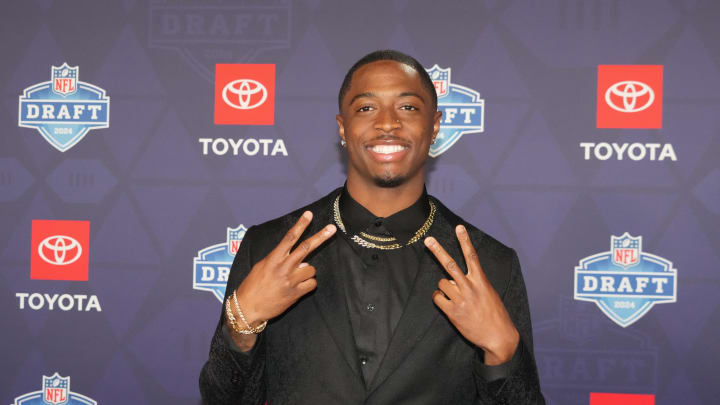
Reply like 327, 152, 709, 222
0, 0, 720, 405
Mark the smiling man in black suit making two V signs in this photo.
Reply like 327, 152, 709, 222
200, 51, 544, 405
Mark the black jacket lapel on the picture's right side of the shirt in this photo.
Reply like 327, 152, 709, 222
368, 204, 464, 393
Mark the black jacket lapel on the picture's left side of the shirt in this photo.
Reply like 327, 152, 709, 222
308, 197, 364, 384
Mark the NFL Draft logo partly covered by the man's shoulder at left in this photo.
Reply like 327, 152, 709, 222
193, 224, 247, 302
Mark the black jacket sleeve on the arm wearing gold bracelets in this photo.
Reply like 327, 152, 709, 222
200, 227, 265, 405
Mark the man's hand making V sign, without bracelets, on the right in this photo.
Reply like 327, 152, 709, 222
425, 225, 520, 366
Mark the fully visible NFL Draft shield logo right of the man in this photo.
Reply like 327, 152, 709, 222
575, 232, 677, 327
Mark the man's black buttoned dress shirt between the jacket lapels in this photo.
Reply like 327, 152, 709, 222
337, 185, 430, 384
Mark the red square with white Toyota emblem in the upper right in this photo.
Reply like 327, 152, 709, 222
597, 65, 663, 129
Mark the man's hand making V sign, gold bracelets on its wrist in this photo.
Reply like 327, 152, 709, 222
226, 211, 336, 340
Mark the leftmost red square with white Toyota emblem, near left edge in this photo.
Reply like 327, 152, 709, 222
30, 219, 90, 281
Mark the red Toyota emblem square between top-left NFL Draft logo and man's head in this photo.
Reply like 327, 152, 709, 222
215, 64, 275, 125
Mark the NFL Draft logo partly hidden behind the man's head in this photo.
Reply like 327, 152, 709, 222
426, 65, 485, 157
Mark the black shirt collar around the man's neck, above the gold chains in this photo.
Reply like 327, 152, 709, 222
340, 187, 430, 244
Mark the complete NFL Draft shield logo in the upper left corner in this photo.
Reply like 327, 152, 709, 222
18, 63, 110, 152
